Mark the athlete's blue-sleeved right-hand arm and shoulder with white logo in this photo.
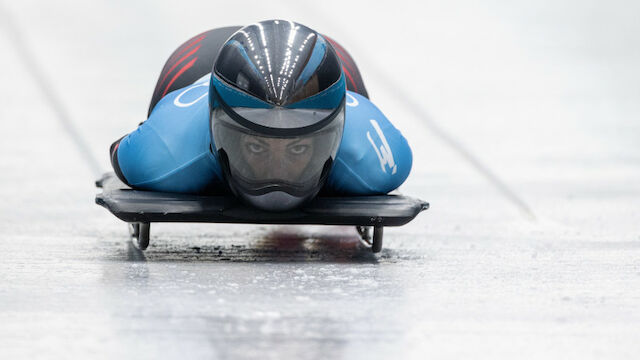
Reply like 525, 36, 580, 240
326, 91, 412, 195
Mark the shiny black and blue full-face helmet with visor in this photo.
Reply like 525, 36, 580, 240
209, 20, 346, 211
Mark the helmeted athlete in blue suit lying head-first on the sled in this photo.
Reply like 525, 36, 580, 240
110, 20, 412, 211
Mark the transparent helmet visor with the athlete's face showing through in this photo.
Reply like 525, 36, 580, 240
212, 108, 344, 211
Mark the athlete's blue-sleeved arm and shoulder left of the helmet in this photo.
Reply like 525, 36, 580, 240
111, 79, 222, 193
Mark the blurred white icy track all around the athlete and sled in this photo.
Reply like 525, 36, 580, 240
0, 0, 640, 359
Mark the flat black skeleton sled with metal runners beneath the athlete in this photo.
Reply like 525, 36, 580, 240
96, 173, 429, 253
